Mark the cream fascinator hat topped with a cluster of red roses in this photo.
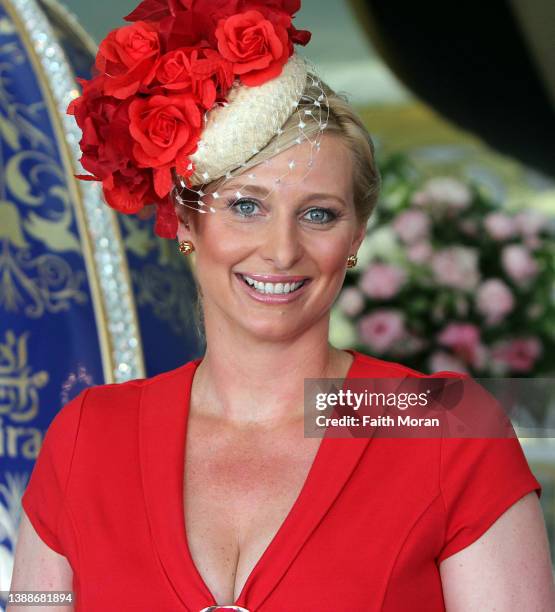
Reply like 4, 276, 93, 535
68, 0, 327, 238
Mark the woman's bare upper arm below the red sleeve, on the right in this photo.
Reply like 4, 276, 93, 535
440, 492, 555, 612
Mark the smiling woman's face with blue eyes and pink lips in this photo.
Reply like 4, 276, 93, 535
176, 135, 365, 340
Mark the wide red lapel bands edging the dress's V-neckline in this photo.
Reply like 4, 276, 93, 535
139, 349, 378, 612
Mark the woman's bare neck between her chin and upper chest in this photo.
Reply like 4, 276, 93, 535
191, 314, 353, 427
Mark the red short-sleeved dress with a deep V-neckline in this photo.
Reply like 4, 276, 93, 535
23, 350, 541, 612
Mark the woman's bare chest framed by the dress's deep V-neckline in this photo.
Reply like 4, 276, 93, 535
183, 419, 320, 604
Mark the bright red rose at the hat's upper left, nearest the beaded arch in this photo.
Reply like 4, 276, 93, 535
96, 21, 160, 100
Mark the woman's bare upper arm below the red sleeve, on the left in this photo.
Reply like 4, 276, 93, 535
6, 511, 73, 612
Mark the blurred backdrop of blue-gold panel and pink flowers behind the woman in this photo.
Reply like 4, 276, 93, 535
0, 0, 555, 590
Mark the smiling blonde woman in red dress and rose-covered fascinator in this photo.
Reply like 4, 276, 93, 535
8, 0, 555, 612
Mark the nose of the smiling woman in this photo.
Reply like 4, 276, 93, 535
261, 215, 303, 270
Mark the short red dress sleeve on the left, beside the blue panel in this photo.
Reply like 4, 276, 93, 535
21, 389, 89, 555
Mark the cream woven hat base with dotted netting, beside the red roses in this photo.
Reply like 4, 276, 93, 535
174, 54, 329, 213
